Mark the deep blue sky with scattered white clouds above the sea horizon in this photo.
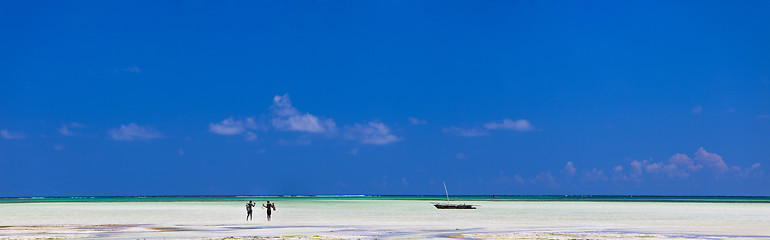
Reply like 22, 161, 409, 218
0, 1, 770, 196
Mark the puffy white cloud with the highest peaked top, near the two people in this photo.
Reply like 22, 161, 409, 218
270, 94, 337, 133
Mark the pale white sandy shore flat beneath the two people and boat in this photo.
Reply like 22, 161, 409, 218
0, 199, 770, 239
